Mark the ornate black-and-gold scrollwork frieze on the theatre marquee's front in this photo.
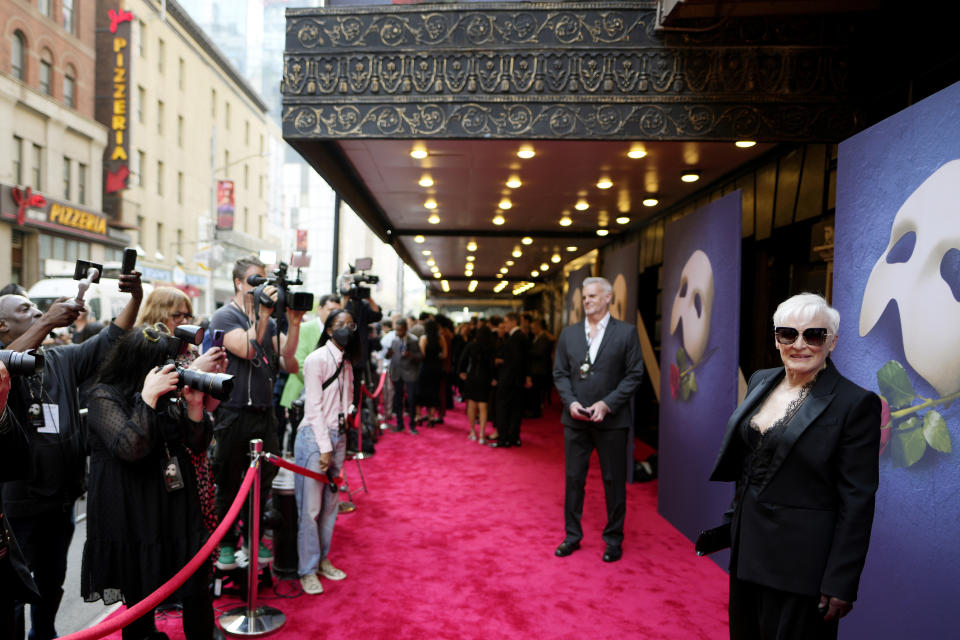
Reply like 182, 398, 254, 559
281, 2, 857, 140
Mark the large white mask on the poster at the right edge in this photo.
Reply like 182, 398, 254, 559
860, 160, 960, 395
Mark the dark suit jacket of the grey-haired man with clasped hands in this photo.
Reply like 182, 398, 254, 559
553, 317, 643, 429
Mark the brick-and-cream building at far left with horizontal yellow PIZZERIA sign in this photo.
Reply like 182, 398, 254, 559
0, 0, 123, 287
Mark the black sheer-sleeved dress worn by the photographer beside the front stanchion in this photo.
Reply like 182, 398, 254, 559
80, 384, 212, 608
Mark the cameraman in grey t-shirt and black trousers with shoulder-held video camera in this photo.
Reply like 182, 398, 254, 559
210, 255, 313, 569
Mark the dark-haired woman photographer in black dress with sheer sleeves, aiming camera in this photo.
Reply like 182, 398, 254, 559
80, 322, 220, 640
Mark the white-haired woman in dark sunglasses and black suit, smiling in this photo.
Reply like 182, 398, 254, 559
711, 293, 880, 640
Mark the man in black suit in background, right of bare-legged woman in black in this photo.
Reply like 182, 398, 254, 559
490, 312, 532, 448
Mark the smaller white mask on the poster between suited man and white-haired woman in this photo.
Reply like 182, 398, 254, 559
670, 249, 713, 364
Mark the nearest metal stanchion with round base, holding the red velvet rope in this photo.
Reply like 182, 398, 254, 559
220, 439, 287, 636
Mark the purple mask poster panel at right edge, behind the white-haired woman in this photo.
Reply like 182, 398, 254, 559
833, 84, 960, 638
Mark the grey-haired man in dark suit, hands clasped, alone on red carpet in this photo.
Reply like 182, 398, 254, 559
553, 278, 643, 562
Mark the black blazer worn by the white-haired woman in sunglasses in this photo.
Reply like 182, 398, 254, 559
710, 359, 880, 602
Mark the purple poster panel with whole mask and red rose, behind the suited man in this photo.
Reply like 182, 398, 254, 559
659, 191, 741, 568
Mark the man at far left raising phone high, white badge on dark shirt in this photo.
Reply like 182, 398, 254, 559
0, 271, 143, 640
